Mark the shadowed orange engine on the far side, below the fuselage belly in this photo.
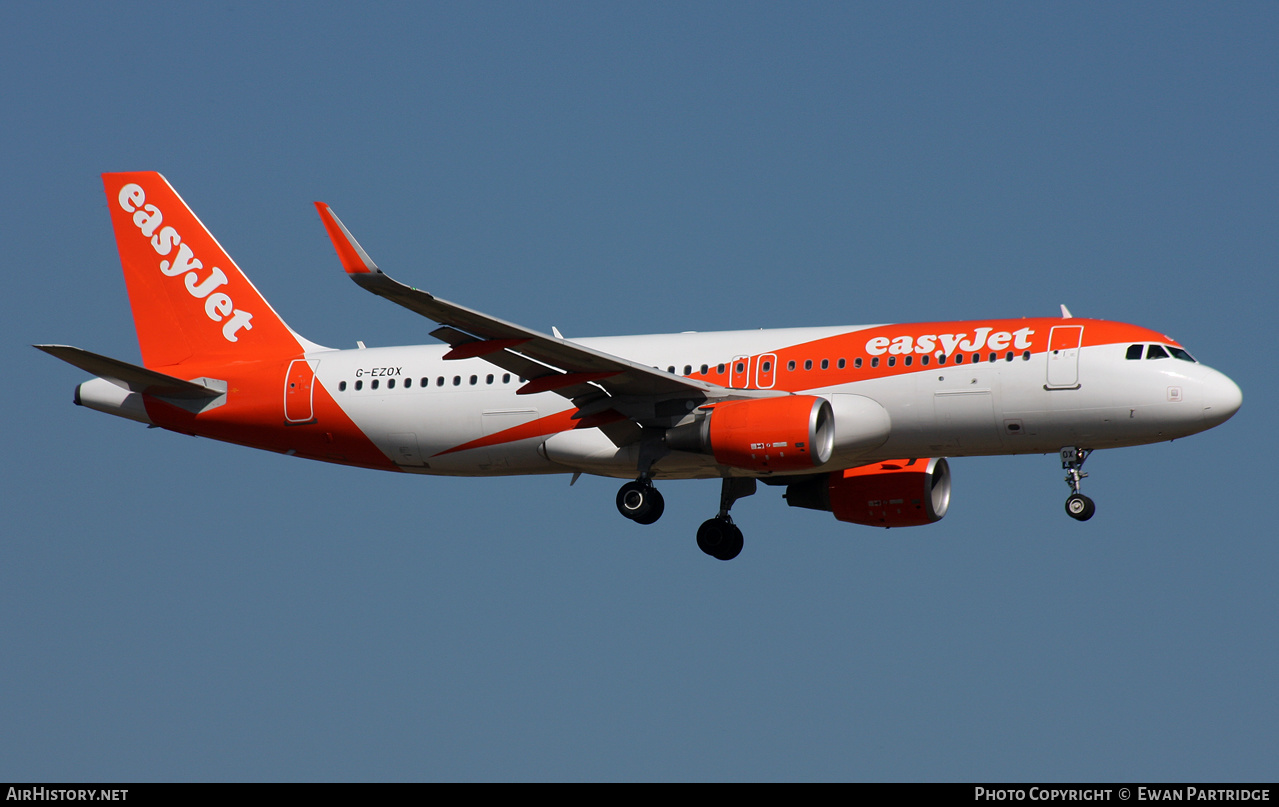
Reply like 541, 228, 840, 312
785, 458, 950, 527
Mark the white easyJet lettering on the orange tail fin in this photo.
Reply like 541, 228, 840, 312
119, 183, 253, 341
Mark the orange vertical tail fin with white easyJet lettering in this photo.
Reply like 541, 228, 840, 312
102, 171, 306, 367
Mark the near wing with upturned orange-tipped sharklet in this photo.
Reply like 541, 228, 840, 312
315, 202, 785, 434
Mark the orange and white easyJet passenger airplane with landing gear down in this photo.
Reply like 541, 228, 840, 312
33, 171, 1243, 560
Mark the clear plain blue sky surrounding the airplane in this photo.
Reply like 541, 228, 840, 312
0, 3, 1279, 781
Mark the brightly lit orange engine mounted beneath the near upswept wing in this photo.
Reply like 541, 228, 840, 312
666, 395, 835, 472
